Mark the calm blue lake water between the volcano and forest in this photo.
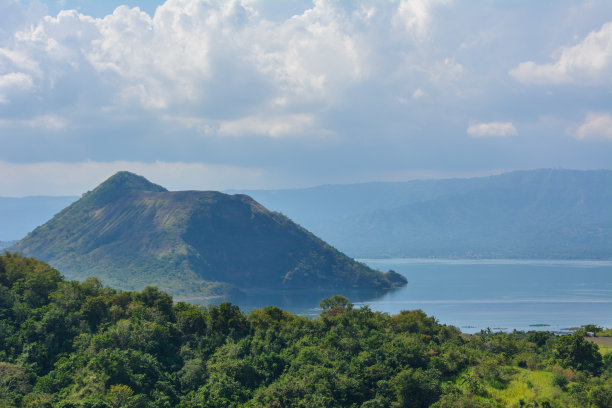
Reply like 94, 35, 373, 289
197, 259, 612, 333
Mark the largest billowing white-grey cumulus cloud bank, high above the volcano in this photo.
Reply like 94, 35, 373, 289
0, 0, 448, 137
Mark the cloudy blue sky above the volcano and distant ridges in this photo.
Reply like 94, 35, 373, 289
0, 0, 612, 196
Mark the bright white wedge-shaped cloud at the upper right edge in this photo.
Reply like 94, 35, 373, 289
510, 22, 612, 85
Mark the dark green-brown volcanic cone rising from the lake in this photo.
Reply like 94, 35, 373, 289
9, 172, 406, 296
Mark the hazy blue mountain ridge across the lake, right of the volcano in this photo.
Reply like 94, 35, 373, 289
237, 170, 612, 259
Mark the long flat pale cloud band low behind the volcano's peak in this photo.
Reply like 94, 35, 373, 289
0, 161, 272, 197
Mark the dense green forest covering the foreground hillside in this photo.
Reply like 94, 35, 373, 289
0, 253, 612, 408
